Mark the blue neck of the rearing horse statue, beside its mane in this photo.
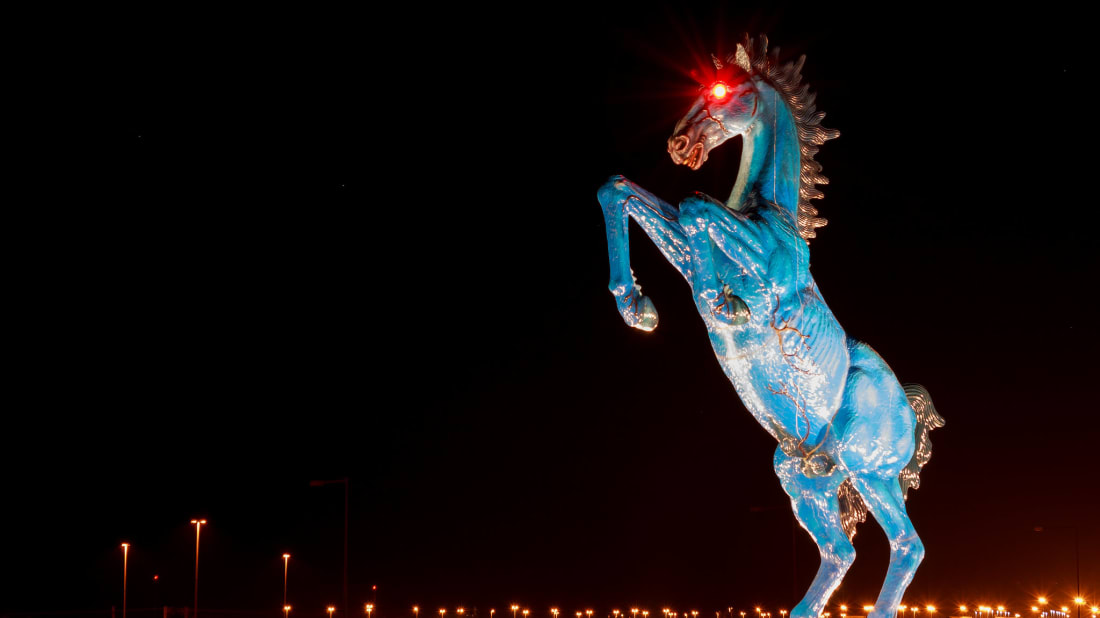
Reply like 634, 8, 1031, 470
726, 78, 802, 220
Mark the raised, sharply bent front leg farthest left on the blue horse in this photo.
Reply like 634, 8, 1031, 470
596, 176, 691, 331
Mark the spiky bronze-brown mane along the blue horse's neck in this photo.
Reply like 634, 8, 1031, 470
726, 34, 840, 241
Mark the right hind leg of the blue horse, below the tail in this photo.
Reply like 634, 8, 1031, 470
851, 476, 924, 618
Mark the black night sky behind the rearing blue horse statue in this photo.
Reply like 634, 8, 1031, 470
0, 2, 1100, 618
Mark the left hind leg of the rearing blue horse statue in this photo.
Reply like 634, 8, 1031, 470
774, 450, 856, 618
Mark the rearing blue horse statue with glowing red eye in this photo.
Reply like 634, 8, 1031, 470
598, 36, 944, 618
